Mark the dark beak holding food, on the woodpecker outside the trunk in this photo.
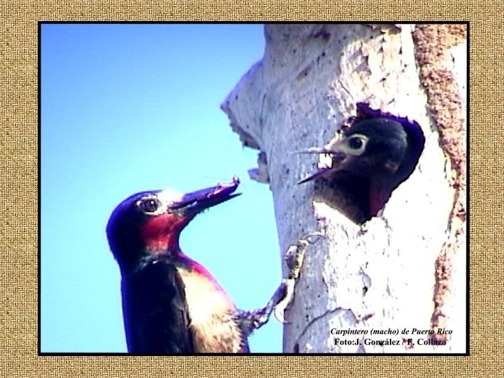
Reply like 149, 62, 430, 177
170, 177, 240, 214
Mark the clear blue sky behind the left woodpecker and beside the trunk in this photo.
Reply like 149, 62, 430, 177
40, 24, 282, 353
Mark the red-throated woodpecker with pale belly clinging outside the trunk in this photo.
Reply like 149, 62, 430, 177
107, 178, 281, 354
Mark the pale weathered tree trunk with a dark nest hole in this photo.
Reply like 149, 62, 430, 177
222, 24, 467, 353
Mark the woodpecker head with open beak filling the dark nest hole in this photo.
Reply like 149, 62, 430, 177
299, 103, 425, 222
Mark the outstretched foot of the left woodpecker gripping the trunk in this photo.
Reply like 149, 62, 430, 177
237, 232, 324, 336
